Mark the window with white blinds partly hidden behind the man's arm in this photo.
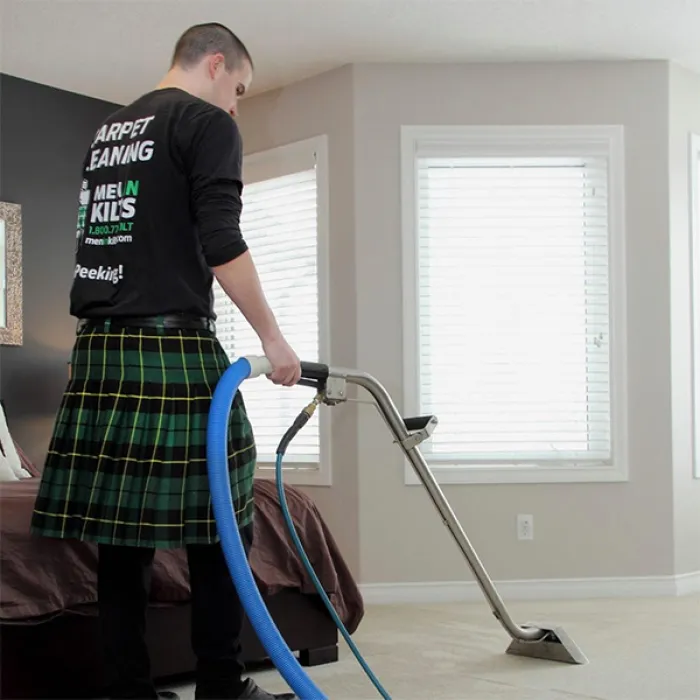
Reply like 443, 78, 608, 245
214, 138, 330, 485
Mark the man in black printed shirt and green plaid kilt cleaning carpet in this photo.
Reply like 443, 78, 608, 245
32, 24, 301, 700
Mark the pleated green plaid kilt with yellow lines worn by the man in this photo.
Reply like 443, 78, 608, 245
31, 324, 256, 548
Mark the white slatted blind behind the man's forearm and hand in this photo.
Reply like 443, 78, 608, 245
214, 167, 320, 465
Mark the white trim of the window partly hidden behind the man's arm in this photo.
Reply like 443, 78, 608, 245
241, 134, 333, 486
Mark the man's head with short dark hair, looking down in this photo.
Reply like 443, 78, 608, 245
170, 22, 253, 117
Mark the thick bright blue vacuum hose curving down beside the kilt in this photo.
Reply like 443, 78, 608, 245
207, 358, 328, 700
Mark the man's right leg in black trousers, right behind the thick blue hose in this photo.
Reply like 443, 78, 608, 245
187, 525, 295, 700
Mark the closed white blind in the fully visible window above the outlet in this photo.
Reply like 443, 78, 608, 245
415, 156, 612, 466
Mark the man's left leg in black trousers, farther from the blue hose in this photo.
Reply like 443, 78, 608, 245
97, 545, 158, 698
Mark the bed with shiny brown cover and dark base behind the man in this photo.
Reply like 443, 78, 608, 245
0, 468, 364, 698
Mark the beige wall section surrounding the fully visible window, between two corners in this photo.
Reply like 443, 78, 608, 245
355, 63, 674, 582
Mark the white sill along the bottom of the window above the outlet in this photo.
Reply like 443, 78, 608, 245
404, 461, 629, 486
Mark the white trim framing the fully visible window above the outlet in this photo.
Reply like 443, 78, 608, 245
401, 125, 629, 485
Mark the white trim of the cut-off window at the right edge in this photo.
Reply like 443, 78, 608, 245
688, 133, 700, 479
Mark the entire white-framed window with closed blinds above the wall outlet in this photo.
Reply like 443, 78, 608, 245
402, 127, 627, 483
